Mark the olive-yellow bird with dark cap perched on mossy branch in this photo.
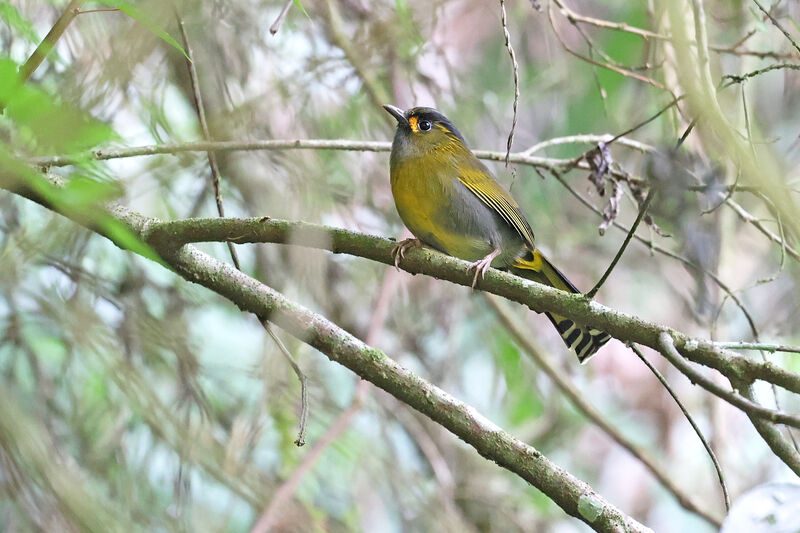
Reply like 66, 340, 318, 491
383, 105, 611, 363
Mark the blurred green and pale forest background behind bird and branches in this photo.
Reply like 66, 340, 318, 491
0, 0, 800, 532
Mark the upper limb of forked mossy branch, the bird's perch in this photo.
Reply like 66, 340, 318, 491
147, 217, 800, 406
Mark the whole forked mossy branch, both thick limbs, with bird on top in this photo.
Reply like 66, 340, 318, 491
6, 170, 800, 531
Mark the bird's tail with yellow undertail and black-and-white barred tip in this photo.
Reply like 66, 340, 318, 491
511, 250, 611, 363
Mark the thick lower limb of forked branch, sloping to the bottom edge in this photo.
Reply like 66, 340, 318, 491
165, 246, 646, 531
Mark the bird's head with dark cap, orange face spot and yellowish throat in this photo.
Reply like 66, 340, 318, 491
383, 105, 468, 161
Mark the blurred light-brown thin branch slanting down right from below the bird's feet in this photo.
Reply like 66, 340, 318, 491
484, 294, 721, 527
